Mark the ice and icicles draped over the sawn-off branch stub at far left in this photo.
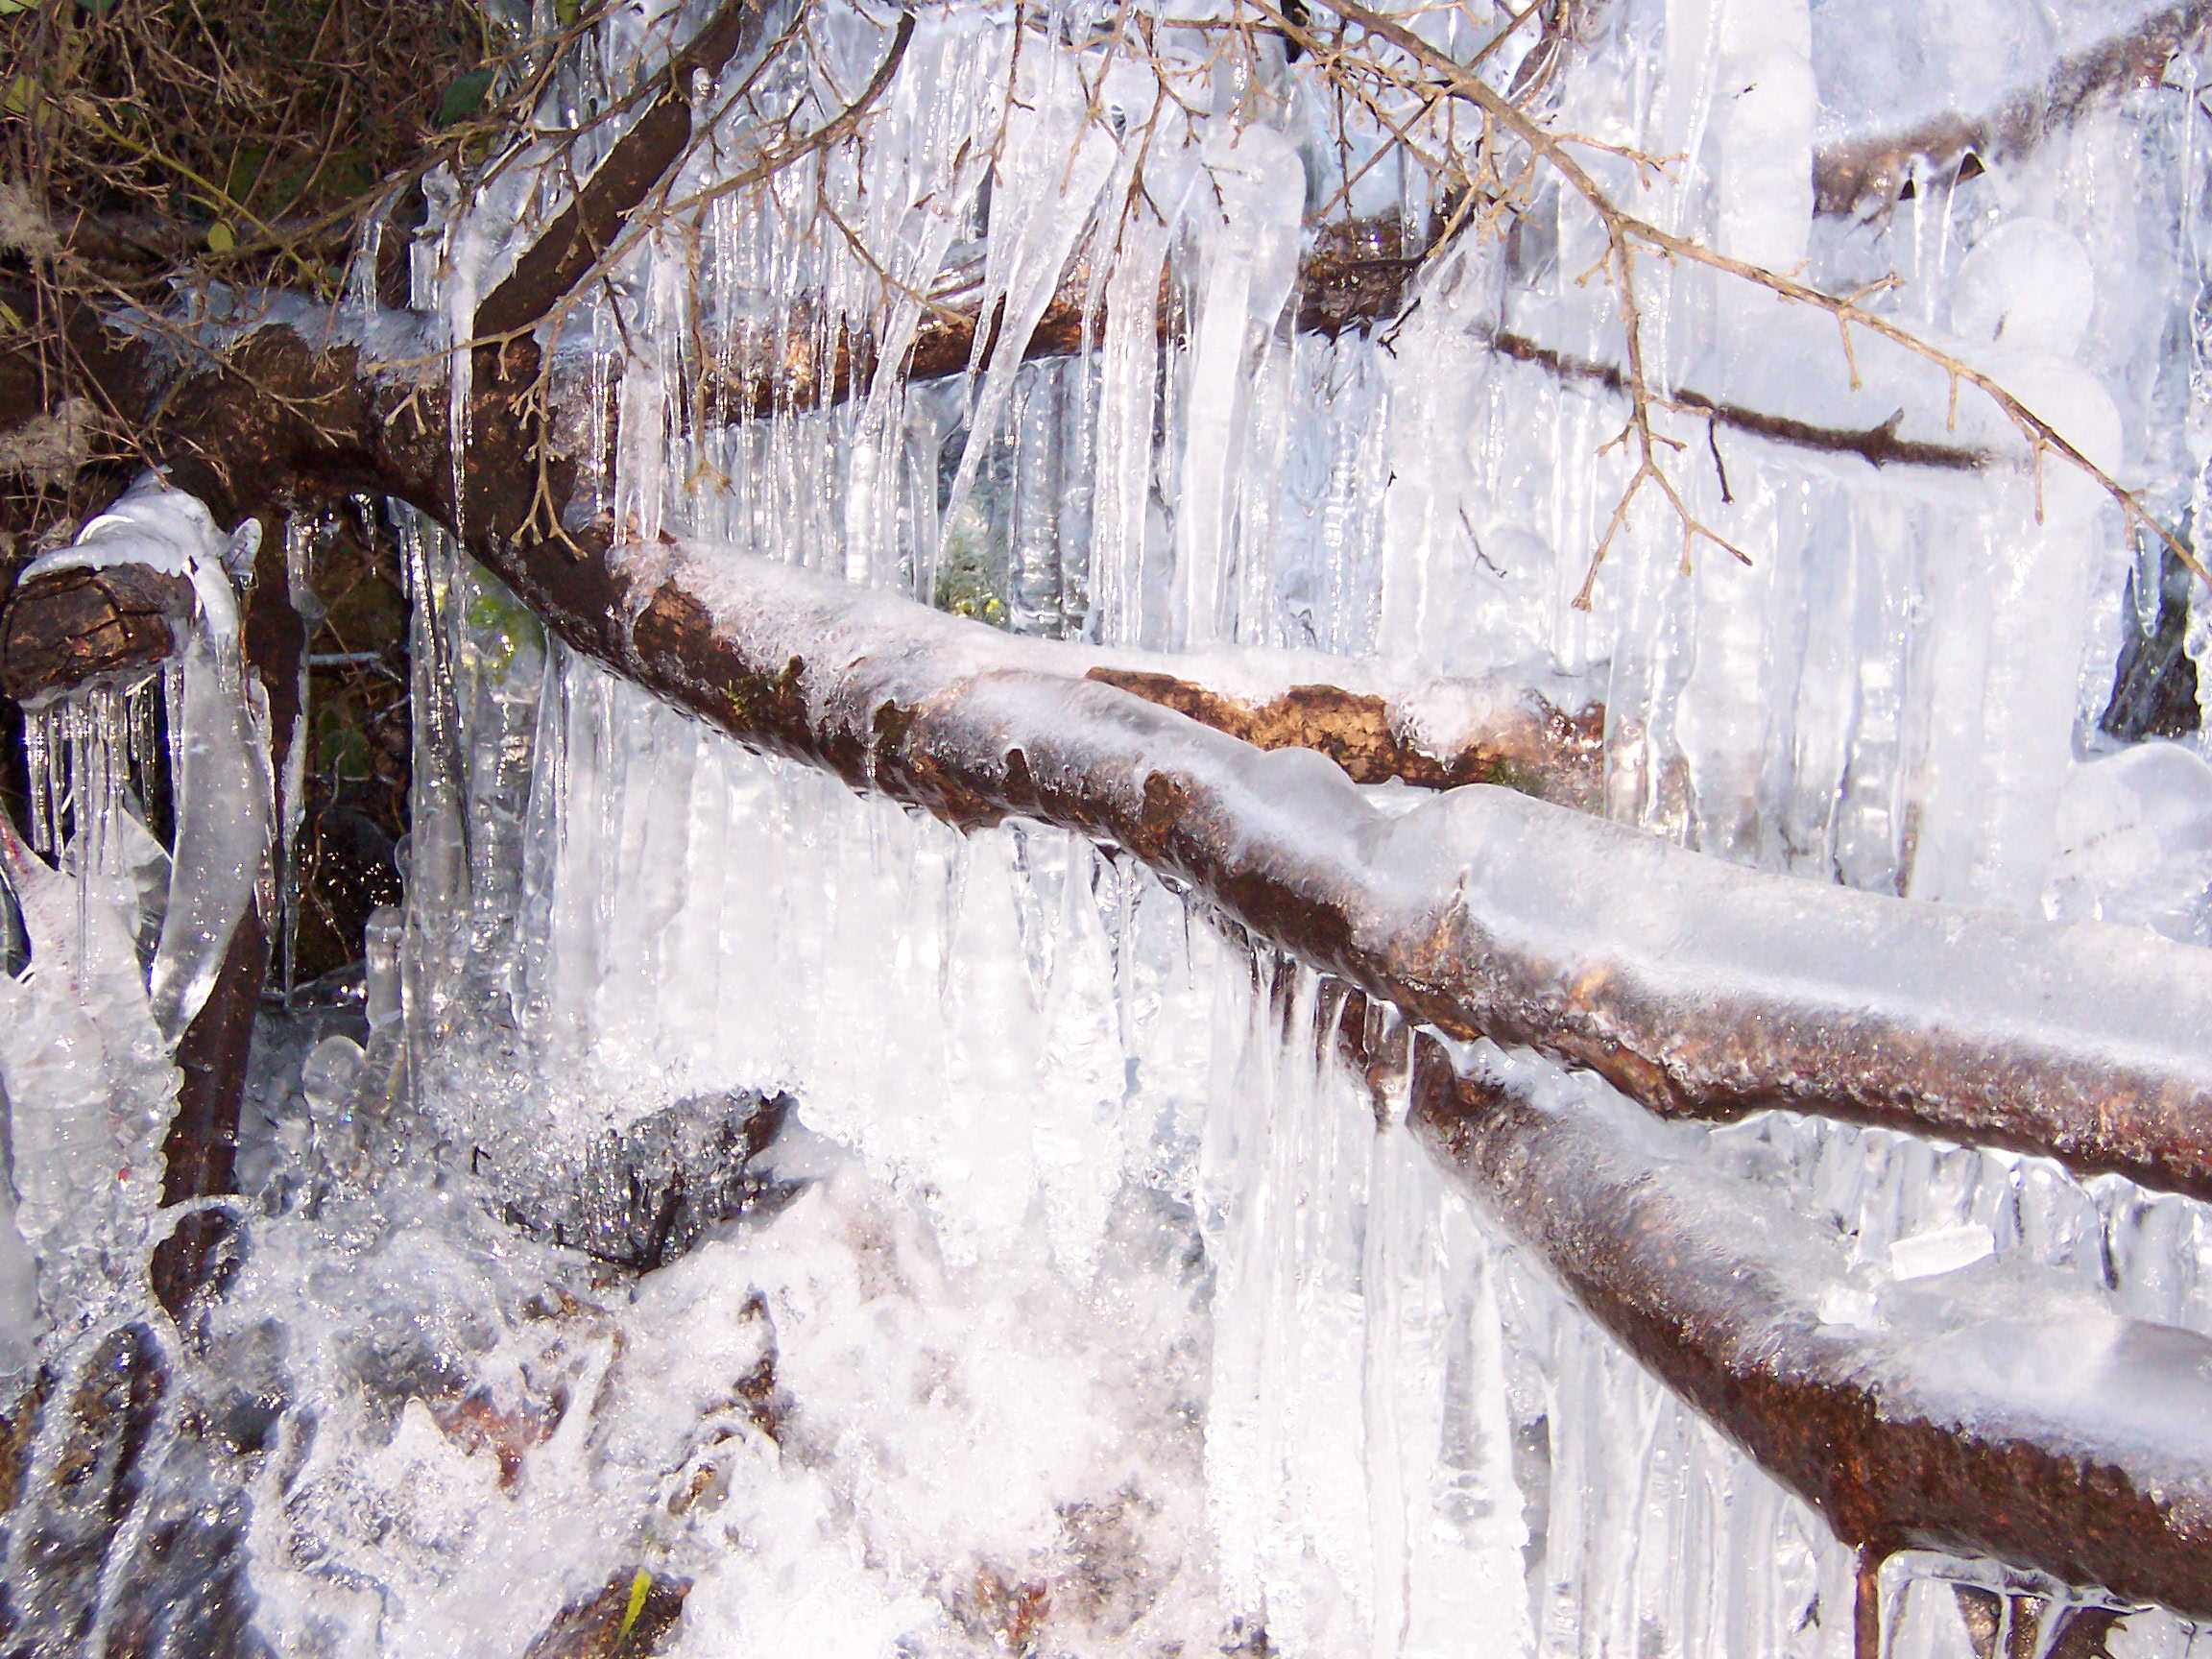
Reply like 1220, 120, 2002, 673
0, 475, 270, 1362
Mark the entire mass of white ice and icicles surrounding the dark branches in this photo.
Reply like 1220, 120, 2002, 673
12, 0, 2212, 1659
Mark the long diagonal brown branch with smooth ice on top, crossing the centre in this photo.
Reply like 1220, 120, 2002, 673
482, 544, 2212, 1196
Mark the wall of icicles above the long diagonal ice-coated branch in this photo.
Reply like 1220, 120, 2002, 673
406, 0, 2212, 909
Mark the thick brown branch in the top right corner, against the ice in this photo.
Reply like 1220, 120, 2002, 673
1814, 0, 2212, 214
